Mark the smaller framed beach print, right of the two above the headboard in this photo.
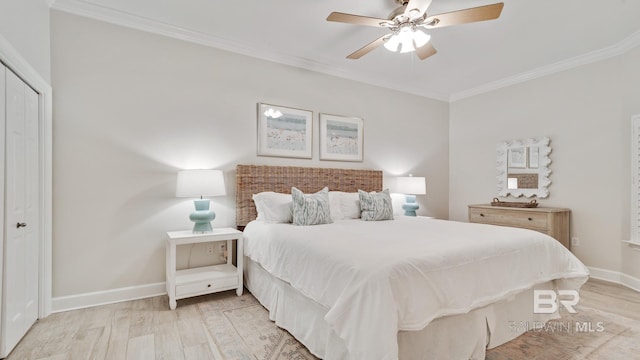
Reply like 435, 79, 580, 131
320, 114, 364, 161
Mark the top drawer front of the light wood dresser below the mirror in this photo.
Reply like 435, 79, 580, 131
469, 208, 548, 229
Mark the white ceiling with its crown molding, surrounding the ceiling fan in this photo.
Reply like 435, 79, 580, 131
50, 0, 640, 100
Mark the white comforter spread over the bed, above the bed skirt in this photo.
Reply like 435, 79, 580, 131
244, 217, 589, 360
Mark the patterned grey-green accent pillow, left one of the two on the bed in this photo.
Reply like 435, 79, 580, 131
291, 187, 333, 225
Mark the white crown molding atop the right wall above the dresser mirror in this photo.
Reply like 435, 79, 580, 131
449, 31, 640, 102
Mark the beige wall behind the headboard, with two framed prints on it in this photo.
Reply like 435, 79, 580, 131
51, 11, 449, 297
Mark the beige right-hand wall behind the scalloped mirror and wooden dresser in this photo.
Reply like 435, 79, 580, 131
449, 49, 640, 278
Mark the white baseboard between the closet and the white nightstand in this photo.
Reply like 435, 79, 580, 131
52, 282, 169, 313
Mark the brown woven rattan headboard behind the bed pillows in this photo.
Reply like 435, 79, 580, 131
236, 165, 382, 228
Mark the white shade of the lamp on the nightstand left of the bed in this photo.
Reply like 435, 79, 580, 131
176, 170, 227, 197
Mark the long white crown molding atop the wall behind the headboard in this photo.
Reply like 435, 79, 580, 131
48, 0, 449, 102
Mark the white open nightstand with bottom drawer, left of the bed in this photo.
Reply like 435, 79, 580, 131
166, 228, 243, 310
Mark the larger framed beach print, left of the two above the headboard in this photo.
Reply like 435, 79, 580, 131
258, 103, 313, 159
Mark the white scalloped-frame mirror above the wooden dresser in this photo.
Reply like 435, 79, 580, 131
497, 137, 551, 198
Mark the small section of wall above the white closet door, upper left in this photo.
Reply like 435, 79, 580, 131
0, 0, 51, 82
